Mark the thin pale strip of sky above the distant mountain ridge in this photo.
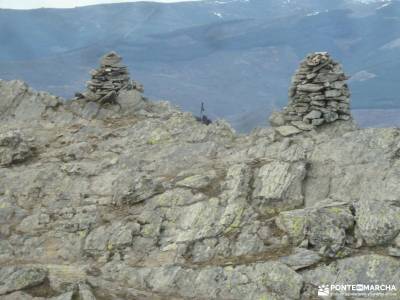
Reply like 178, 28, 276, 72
0, 0, 195, 9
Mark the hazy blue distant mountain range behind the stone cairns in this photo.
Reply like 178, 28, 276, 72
0, 0, 400, 131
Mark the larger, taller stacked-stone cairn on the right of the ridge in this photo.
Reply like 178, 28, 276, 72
270, 52, 351, 135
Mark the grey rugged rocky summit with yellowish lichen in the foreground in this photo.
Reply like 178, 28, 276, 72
0, 54, 400, 300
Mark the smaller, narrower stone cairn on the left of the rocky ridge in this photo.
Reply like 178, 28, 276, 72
75, 52, 144, 104
